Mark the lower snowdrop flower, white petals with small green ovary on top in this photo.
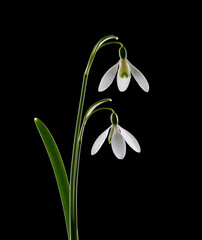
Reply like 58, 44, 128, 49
91, 113, 140, 159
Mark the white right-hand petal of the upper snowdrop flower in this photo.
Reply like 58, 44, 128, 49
127, 60, 149, 92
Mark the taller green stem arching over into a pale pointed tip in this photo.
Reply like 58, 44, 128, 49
69, 35, 118, 240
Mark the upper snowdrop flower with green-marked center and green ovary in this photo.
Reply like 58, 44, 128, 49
98, 47, 149, 92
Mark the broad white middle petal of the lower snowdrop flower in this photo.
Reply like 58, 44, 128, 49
111, 126, 126, 159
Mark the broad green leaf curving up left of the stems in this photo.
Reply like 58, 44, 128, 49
34, 118, 70, 238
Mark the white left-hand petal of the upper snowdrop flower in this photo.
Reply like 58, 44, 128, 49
98, 62, 119, 92
